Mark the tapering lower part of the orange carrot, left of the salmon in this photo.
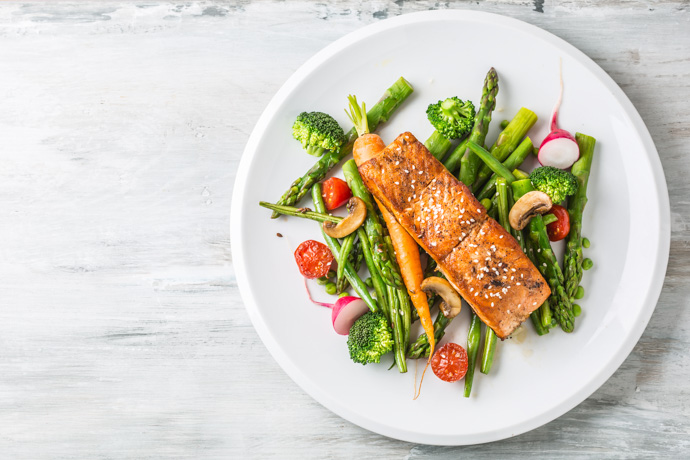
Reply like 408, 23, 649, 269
376, 196, 436, 399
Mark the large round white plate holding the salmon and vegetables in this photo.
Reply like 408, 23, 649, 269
231, 11, 670, 445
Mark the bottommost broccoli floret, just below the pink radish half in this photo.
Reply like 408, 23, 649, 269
347, 312, 393, 364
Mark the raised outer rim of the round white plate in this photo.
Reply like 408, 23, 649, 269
230, 10, 671, 446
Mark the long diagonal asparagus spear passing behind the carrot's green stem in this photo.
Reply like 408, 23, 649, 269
271, 77, 413, 219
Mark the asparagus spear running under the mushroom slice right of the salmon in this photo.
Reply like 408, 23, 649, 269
513, 179, 574, 332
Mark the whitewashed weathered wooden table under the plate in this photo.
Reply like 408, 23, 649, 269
0, 0, 690, 459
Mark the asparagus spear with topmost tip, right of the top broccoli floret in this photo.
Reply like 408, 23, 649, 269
460, 67, 498, 187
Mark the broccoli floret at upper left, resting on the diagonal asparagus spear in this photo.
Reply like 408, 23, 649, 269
292, 112, 345, 156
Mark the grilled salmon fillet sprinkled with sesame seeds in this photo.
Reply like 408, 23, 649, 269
355, 133, 551, 339
